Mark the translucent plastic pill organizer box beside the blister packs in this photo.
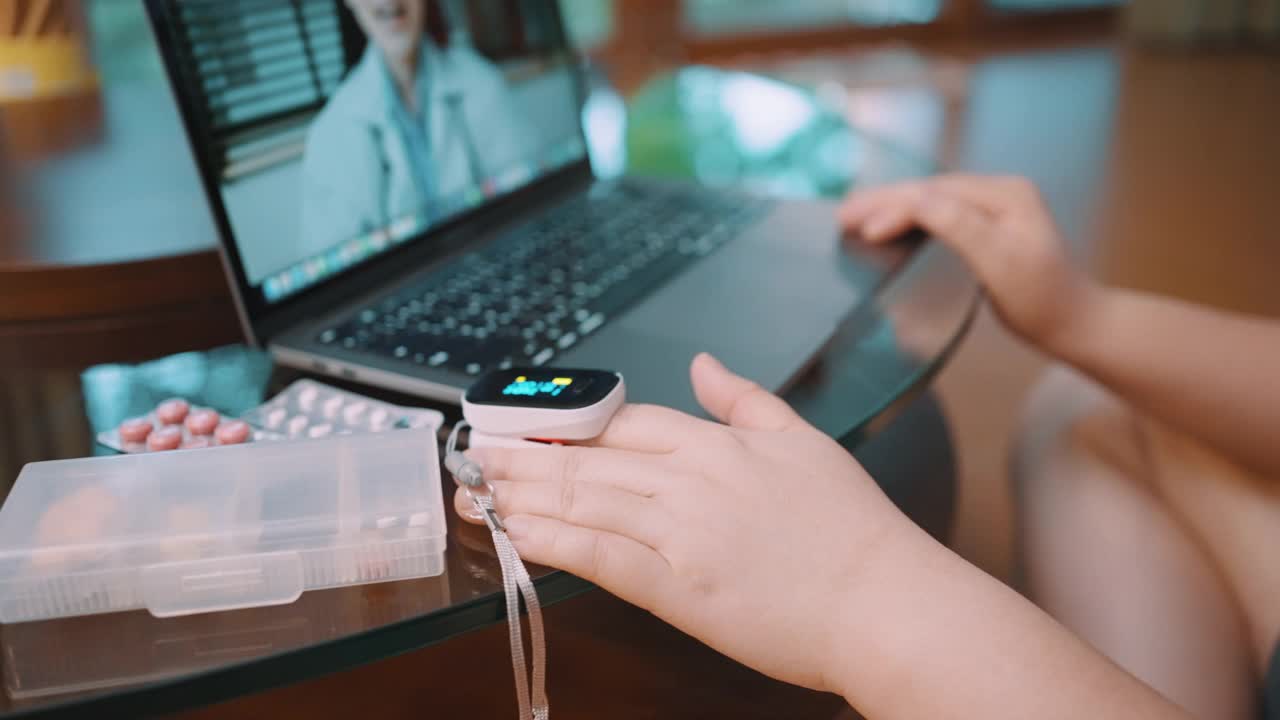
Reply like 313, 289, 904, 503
0, 430, 445, 623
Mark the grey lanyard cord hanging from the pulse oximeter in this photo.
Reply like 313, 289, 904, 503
444, 420, 550, 720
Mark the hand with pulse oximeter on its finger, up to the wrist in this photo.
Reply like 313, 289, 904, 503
458, 355, 922, 692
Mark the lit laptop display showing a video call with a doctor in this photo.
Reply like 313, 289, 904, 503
154, 0, 585, 304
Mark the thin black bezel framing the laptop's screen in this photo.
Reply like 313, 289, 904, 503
145, 0, 594, 346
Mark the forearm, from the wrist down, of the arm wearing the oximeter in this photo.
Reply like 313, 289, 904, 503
831, 520, 1185, 720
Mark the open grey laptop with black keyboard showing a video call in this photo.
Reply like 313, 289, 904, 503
147, 0, 904, 413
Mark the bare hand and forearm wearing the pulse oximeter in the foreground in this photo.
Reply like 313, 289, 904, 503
458, 175, 1185, 720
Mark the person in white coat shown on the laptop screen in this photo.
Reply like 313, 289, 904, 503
301, 0, 536, 251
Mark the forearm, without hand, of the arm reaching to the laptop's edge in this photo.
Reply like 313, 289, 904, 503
1047, 288, 1280, 477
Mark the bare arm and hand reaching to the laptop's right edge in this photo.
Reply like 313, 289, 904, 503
844, 176, 1280, 477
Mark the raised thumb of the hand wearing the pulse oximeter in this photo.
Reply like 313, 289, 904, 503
690, 352, 804, 430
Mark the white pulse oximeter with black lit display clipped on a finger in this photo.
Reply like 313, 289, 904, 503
462, 368, 626, 439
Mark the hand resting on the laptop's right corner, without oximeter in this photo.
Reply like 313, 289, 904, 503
840, 176, 1102, 354
